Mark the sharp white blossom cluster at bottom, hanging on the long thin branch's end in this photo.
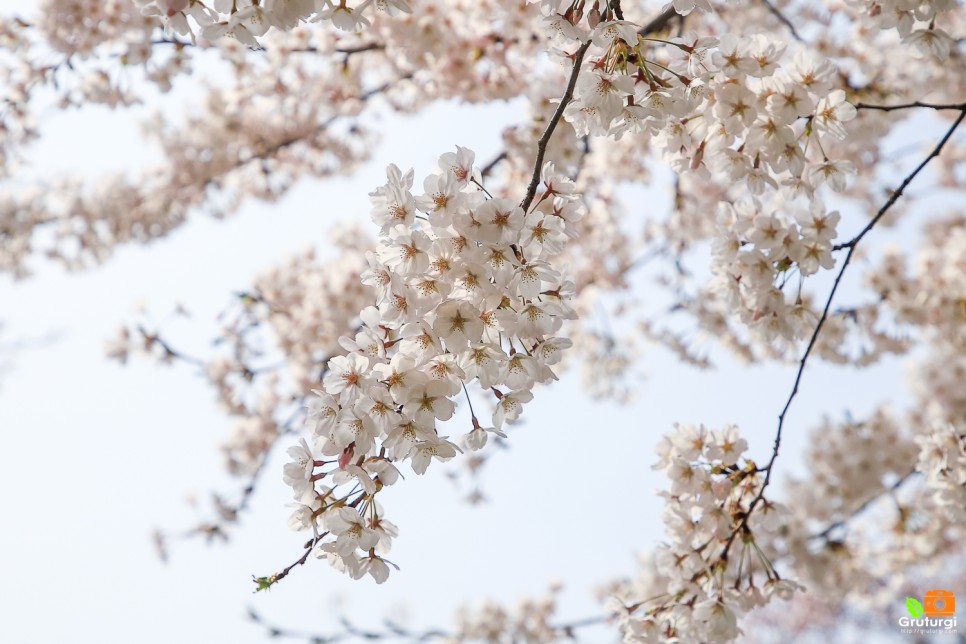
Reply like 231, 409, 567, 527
610, 425, 800, 642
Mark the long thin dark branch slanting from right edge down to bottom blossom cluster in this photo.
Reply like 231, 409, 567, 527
721, 107, 966, 560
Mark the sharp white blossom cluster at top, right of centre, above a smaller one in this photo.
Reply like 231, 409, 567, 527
543, 16, 856, 196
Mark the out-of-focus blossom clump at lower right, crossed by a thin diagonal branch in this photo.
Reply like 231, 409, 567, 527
760, 405, 966, 614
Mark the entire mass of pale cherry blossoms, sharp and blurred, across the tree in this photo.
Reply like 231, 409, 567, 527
7, 0, 966, 642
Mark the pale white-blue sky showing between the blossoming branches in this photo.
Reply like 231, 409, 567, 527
0, 2, 936, 644
